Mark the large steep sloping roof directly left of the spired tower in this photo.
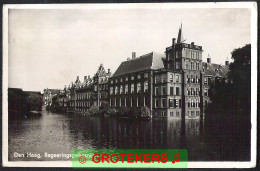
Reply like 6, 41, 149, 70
112, 52, 165, 77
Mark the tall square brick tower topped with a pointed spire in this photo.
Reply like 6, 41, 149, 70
165, 25, 203, 118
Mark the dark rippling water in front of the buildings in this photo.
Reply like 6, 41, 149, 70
8, 111, 250, 161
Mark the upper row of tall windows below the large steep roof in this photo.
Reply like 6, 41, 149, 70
110, 81, 148, 95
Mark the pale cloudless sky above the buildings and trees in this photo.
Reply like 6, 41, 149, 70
8, 8, 251, 92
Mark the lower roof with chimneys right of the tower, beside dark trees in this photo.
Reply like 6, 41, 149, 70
202, 62, 228, 77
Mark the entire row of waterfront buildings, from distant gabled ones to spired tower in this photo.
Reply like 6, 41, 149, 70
47, 27, 229, 119
